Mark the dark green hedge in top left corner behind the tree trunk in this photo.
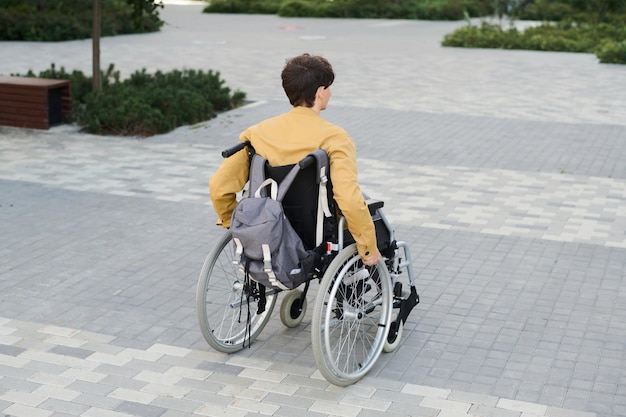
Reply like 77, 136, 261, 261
0, 0, 163, 41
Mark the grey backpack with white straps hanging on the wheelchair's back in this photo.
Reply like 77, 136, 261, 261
230, 151, 330, 290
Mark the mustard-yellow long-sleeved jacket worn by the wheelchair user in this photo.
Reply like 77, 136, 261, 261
209, 107, 377, 258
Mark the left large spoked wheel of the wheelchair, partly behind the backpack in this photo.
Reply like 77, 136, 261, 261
196, 231, 277, 353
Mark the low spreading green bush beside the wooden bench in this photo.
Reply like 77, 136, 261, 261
18, 64, 246, 137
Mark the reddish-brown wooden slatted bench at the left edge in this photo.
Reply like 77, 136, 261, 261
0, 76, 72, 129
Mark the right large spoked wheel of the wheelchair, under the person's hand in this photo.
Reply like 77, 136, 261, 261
311, 244, 393, 386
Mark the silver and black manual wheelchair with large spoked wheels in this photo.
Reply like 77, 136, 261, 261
196, 143, 419, 386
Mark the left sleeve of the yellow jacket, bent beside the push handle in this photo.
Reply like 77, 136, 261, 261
209, 144, 250, 228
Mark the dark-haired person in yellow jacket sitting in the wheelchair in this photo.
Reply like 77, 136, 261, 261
209, 54, 381, 265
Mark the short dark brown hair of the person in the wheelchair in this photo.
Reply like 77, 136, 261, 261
281, 54, 335, 107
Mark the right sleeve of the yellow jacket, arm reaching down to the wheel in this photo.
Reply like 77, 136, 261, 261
326, 133, 377, 258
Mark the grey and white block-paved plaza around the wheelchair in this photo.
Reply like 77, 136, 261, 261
0, 1, 626, 417
